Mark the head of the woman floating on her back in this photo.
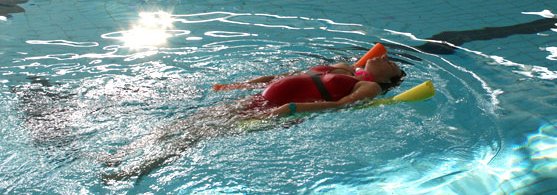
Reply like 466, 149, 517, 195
364, 56, 406, 94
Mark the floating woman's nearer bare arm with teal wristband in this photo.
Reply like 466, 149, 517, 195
270, 81, 381, 116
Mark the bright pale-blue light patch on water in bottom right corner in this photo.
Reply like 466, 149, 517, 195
314, 124, 557, 194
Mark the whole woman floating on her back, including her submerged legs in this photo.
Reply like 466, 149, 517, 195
103, 46, 406, 182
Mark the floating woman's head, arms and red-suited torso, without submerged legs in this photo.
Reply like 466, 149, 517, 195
236, 56, 406, 116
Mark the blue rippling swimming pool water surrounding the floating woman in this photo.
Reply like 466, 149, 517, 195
0, 0, 557, 194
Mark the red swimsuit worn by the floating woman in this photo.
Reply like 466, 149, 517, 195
262, 66, 358, 106
